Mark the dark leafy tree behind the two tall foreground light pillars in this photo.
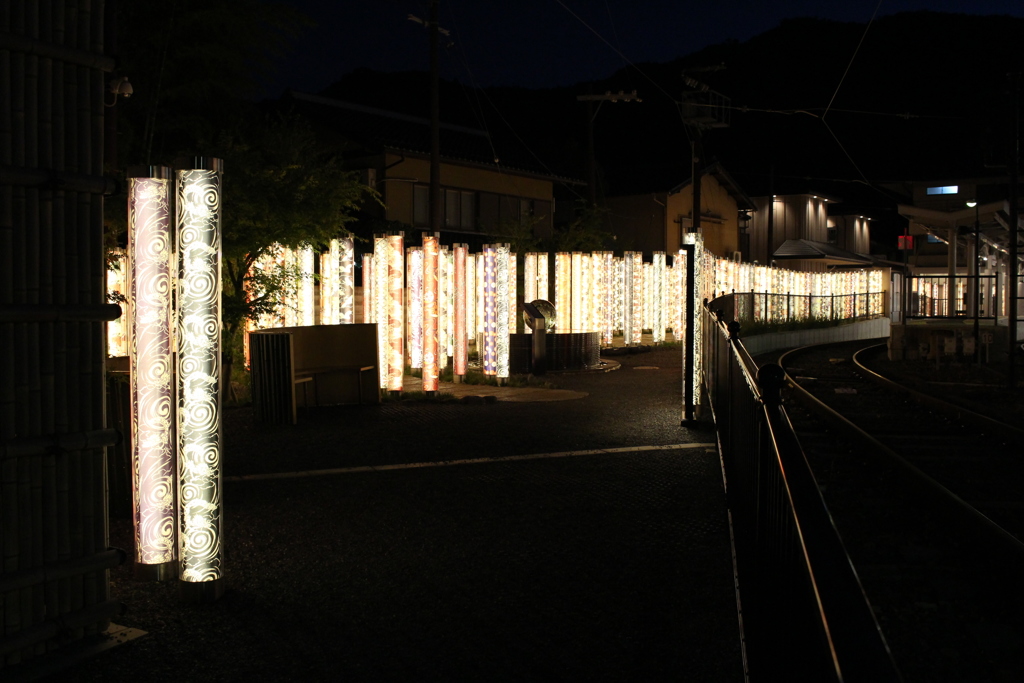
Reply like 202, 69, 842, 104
108, 0, 375, 360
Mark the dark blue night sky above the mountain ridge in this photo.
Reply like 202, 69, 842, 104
263, 0, 1024, 97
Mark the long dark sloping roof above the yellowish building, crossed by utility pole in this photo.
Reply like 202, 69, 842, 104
285, 90, 580, 183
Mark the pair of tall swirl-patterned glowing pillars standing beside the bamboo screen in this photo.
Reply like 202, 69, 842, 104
128, 159, 223, 600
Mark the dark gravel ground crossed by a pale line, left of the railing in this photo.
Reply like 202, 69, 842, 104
44, 350, 742, 682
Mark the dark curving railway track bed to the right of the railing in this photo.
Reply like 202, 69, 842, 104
779, 341, 1024, 682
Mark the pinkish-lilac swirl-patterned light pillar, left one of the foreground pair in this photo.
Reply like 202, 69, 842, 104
122, 166, 177, 581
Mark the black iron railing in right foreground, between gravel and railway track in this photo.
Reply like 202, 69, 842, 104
701, 297, 900, 683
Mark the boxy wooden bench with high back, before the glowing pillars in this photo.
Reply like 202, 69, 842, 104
249, 325, 380, 424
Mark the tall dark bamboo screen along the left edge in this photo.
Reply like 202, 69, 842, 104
0, 0, 119, 678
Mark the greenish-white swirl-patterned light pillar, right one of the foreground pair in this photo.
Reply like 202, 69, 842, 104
176, 159, 224, 602
